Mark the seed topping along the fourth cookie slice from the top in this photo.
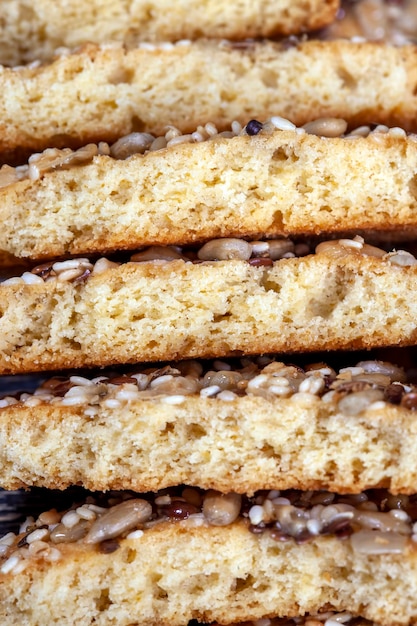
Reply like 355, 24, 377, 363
2, 235, 417, 285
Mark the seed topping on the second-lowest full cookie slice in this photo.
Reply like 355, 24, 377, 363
0, 357, 417, 418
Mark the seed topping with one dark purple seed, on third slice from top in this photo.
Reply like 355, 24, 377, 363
0, 116, 410, 188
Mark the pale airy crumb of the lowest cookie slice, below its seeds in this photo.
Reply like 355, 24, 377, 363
0, 523, 417, 626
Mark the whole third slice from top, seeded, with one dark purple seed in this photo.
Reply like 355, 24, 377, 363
4, 122, 417, 259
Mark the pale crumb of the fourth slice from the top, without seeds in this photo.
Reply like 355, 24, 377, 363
0, 249, 417, 374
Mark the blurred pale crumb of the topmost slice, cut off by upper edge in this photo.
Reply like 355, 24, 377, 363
0, 0, 339, 65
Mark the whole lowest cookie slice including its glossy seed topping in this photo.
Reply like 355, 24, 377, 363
0, 488, 417, 626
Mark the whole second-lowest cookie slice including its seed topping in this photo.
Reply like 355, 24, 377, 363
0, 358, 417, 493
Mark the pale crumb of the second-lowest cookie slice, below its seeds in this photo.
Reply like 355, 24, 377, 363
0, 392, 417, 493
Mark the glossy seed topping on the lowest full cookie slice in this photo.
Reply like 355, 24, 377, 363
0, 487, 417, 574
